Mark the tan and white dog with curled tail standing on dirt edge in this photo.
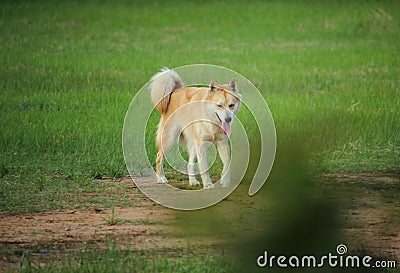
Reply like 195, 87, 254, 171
150, 68, 242, 189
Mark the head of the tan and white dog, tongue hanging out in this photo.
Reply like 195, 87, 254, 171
207, 79, 242, 136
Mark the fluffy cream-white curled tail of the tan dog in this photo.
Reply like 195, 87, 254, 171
150, 67, 183, 113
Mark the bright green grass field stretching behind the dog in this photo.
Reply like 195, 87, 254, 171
0, 1, 400, 272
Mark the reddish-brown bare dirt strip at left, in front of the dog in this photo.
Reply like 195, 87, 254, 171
0, 177, 223, 272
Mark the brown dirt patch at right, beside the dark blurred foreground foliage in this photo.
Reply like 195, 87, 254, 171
324, 172, 400, 262
